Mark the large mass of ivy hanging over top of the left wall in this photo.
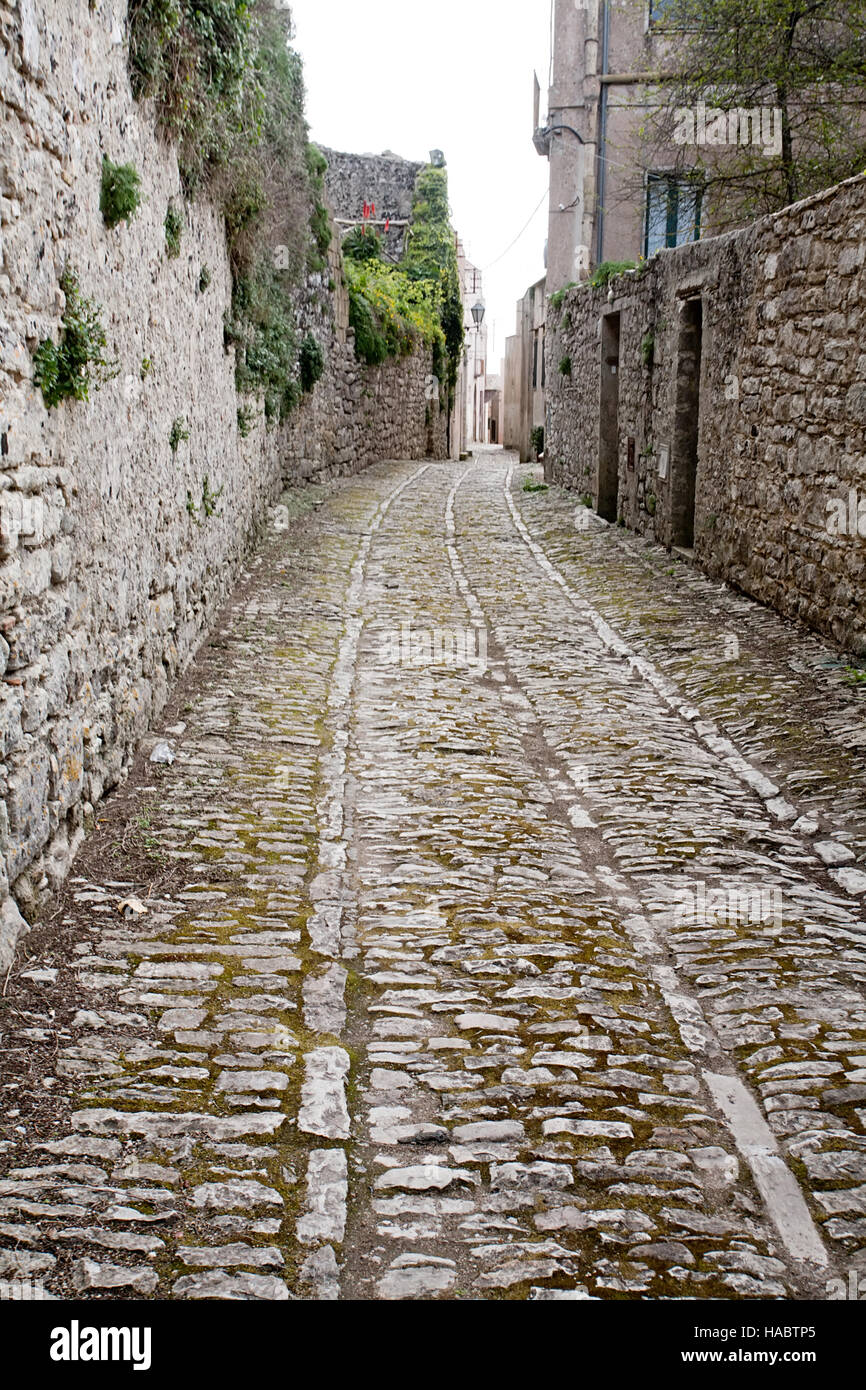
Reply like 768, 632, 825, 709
129, 0, 331, 420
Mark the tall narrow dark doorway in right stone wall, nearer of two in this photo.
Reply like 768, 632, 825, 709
670, 297, 703, 550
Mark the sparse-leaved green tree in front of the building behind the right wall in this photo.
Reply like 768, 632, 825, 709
645, 0, 866, 227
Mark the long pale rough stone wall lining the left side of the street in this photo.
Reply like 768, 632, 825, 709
0, 0, 438, 966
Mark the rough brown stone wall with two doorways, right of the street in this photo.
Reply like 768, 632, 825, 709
546, 178, 866, 653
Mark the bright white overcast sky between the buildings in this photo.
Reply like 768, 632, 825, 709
291, 0, 550, 371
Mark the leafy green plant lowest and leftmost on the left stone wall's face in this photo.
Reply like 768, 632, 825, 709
33, 265, 120, 410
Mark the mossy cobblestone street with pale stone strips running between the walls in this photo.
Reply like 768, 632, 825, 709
0, 450, 866, 1300
